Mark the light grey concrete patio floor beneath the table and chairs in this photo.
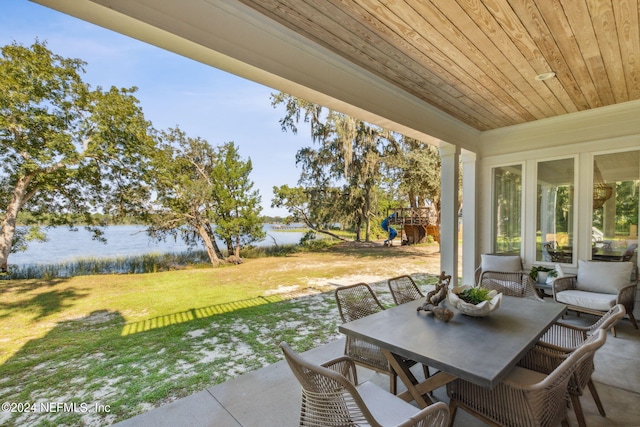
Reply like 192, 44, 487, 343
116, 302, 640, 427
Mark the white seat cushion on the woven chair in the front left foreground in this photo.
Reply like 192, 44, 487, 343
357, 381, 420, 426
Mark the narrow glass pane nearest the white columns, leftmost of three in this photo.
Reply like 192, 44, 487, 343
493, 165, 522, 255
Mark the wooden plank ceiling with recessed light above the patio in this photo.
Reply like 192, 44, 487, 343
240, 0, 640, 131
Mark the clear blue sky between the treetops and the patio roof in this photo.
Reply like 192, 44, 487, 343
0, 0, 312, 216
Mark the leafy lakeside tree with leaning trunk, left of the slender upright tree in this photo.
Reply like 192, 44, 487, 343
146, 129, 224, 266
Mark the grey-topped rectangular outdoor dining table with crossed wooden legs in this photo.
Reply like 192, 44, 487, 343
339, 295, 566, 408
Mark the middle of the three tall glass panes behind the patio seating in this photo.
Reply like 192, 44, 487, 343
536, 158, 575, 264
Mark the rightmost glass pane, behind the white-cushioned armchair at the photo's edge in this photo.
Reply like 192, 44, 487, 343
591, 151, 640, 262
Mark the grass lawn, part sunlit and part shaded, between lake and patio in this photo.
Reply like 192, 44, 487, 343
0, 245, 439, 426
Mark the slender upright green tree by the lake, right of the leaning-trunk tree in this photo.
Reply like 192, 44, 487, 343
211, 142, 265, 262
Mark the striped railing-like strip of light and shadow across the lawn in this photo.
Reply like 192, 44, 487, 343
121, 295, 285, 336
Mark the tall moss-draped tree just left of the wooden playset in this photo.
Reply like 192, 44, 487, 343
272, 93, 391, 241
